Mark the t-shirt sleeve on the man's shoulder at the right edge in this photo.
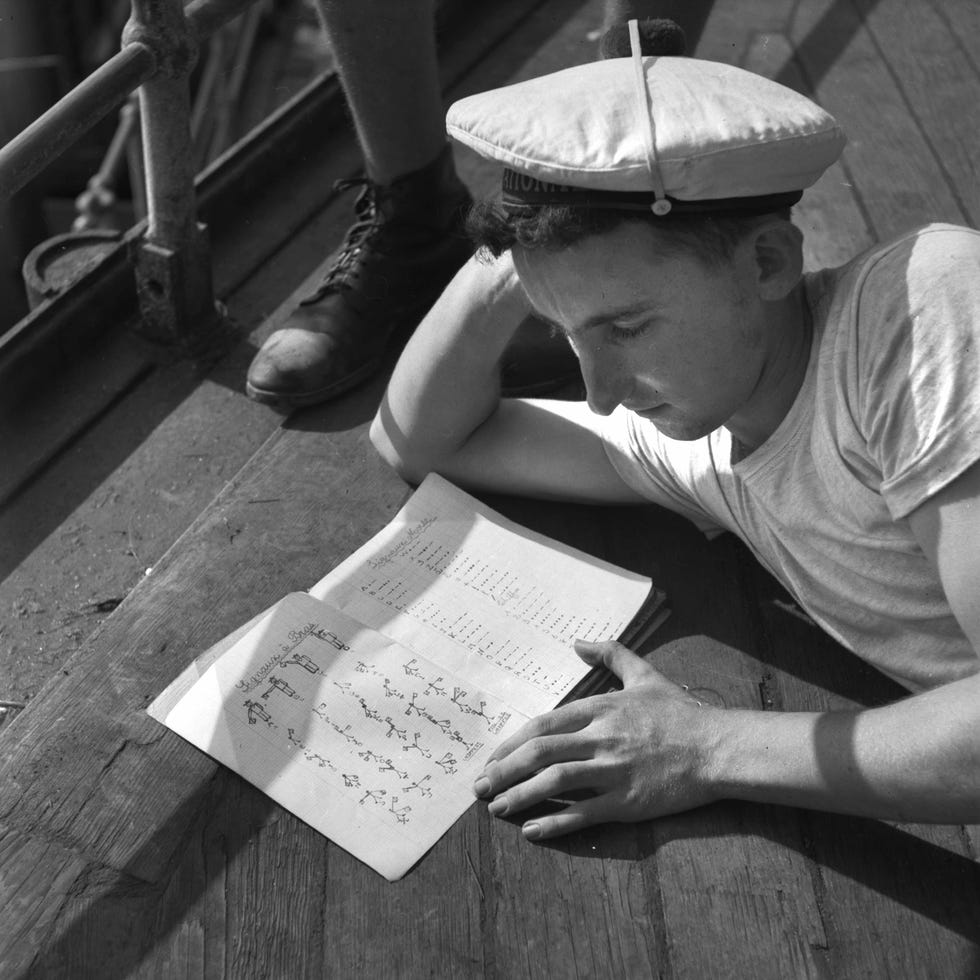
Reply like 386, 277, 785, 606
856, 226, 980, 520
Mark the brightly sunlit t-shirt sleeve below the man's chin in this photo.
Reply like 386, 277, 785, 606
600, 406, 725, 537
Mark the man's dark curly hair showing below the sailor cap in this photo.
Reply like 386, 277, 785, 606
466, 201, 790, 265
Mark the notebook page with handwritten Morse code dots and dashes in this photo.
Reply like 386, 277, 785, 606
310, 474, 651, 715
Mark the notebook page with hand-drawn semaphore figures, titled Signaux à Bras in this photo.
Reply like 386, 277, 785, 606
165, 593, 526, 881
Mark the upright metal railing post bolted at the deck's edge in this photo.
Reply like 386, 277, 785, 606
123, 0, 217, 349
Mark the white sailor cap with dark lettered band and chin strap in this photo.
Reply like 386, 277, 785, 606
447, 21, 845, 215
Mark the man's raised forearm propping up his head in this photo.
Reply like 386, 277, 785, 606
371, 256, 529, 481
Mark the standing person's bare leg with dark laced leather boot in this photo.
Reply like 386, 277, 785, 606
246, 0, 471, 408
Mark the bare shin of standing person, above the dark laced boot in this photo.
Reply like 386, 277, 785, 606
318, 0, 446, 184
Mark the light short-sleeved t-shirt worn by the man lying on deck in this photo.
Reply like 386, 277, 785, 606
603, 225, 980, 690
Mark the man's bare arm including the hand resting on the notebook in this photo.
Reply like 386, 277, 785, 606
477, 463, 980, 839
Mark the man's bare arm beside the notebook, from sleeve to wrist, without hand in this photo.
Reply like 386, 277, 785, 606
716, 402, 980, 823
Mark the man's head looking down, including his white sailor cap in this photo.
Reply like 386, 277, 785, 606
447, 17, 844, 439
